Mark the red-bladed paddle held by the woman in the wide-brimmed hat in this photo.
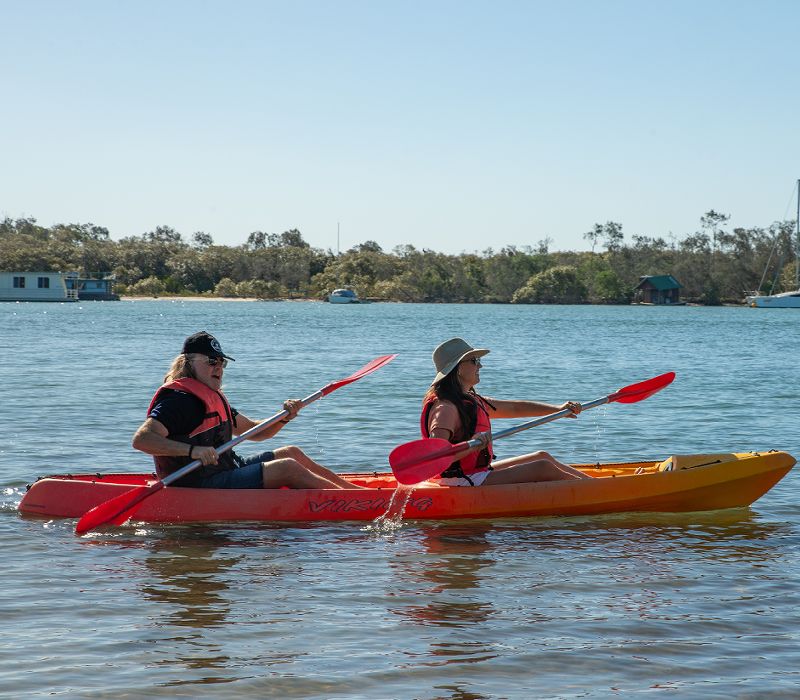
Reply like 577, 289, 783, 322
389, 372, 675, 484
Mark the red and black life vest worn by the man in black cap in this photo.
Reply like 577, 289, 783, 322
147, 377, 236, 485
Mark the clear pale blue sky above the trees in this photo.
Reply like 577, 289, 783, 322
0, 0, 800, 254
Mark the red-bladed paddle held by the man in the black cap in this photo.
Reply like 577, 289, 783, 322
75, 355, 397, 535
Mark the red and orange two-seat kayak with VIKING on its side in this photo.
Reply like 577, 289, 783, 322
19, 452, 795, 523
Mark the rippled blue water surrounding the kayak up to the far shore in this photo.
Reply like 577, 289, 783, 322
0, 301, 800, 700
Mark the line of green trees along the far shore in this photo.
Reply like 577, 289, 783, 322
0, 210, 794, 304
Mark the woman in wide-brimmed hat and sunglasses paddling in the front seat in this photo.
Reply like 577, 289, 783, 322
420, 338, 591, 486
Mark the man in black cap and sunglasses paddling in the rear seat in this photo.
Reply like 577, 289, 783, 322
132, 331, 360, 489
